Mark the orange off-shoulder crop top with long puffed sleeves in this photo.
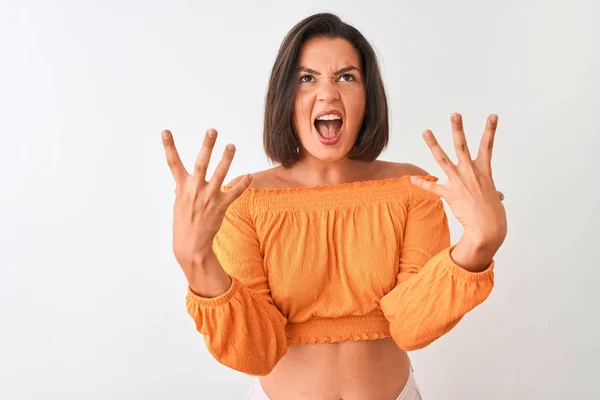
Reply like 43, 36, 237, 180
186, 175, 494, 375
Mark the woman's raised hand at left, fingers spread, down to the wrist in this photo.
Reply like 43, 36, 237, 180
162, 129, 252, 282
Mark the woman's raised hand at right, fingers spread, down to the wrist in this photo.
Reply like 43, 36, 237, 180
411, 113, 506, 252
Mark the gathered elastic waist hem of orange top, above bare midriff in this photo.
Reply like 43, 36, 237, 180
285, 311, 392, 345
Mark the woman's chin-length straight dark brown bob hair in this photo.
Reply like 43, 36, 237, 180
263, 13, 389, 168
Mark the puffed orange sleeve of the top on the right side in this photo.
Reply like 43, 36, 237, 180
380, 176, 494, 351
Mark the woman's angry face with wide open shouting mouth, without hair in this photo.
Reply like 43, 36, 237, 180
294, 37, 366, 161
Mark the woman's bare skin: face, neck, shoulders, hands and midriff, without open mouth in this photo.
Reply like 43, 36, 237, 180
163, 38, 506, 400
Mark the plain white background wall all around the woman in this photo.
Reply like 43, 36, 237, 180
0, 0, 600, 400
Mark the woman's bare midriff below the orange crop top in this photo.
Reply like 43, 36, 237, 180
260, 338, 410, 400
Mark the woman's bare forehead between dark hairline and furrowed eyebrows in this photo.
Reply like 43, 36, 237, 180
298, 37, 361, 70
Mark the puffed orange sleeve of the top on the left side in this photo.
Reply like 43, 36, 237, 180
186, 191, 287, 375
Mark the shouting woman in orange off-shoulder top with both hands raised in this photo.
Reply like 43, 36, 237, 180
163, 14, 506, 400
